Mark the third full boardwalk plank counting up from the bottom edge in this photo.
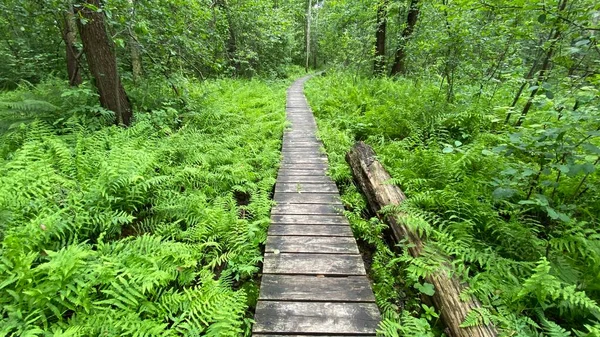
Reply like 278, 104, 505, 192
263, 253, 366, 276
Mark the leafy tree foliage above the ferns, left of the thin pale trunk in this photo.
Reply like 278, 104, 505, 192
0, 0, 306, 88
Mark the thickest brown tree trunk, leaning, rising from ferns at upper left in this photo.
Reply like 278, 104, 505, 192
77, 0, 132, 125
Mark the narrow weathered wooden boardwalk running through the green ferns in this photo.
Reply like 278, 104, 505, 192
253, 77, 380, 337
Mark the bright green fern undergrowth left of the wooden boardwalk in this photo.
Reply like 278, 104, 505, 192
0, 80, 286, 336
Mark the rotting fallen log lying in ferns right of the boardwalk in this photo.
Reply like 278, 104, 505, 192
346, 142, 498, 337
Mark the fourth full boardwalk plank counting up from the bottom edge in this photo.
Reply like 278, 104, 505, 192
265, 236, 359, 254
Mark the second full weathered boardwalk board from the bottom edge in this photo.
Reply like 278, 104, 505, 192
259, 274, 375, 302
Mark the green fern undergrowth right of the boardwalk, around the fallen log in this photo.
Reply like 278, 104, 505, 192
306, 73, 600, 336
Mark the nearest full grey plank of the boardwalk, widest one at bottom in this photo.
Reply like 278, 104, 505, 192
252, 301, 380, 335
